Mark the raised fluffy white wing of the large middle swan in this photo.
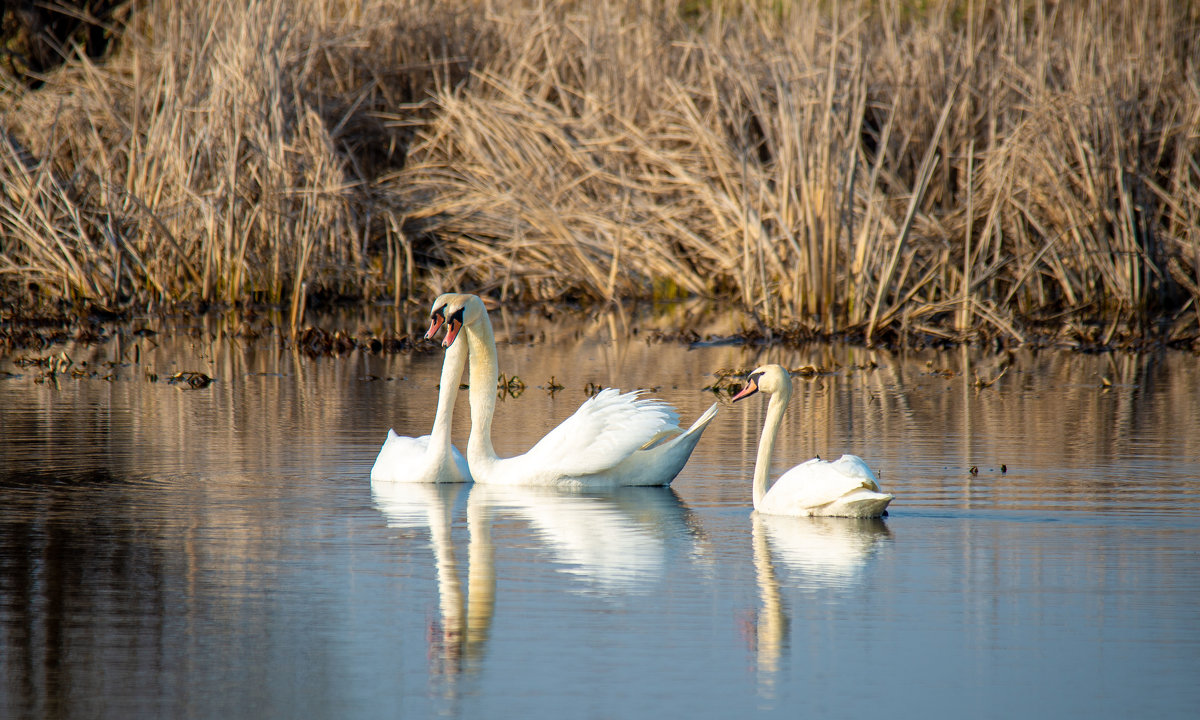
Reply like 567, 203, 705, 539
523, 388, 679, 476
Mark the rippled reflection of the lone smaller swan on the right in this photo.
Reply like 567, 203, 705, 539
751, 512, 892, 698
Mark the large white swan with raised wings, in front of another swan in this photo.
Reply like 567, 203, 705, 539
433, 293, 716, 488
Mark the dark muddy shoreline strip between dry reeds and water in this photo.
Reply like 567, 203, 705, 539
0, 300, 1200, 356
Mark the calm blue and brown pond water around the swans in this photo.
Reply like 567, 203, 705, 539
0, 306, 1200, 718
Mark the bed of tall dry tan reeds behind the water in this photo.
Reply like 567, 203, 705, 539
0, 0, 1200, 343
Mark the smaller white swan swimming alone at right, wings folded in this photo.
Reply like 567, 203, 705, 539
729, 365, 894, 517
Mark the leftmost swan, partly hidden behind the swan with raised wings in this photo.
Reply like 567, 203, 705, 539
371, 304, 470, 484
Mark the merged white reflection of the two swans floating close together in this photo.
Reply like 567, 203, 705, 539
371, 482, 695, 696
